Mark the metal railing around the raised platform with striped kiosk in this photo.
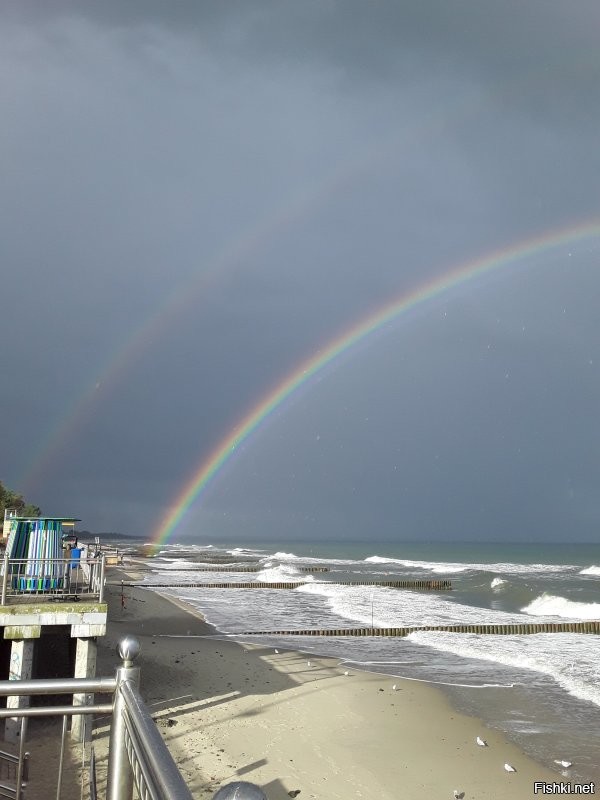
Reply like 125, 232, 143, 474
0, 553, 105, 606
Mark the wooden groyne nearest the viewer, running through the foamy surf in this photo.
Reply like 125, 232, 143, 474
238, 620, 600, 636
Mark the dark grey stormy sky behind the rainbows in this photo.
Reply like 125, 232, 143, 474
0, 0, 600, 541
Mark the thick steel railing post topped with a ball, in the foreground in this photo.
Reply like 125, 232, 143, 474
106, 636, 140, 800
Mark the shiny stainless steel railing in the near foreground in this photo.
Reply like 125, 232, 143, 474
0, 636, 266, 800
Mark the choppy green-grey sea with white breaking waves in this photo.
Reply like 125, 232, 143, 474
118, 540, 600, 785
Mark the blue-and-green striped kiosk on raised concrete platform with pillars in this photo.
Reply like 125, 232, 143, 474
0, 512, 107, 741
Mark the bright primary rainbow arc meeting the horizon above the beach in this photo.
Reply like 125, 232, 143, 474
152, 219, 600, 545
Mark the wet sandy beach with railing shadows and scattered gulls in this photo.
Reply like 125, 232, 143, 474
98, 566, 565, 800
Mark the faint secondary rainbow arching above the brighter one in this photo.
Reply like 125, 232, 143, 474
17, 75, 540, 495
